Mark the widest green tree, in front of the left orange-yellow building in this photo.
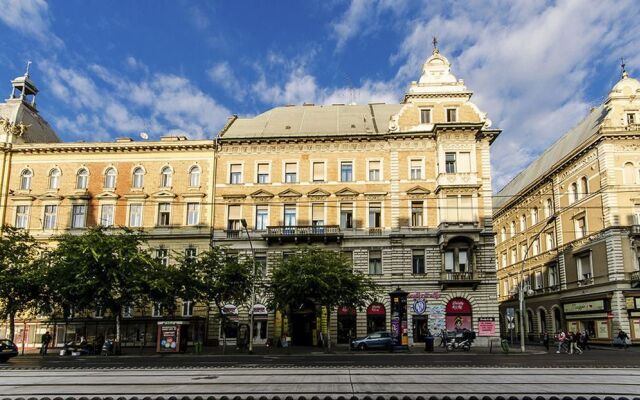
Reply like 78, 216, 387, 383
49, 226, 167, 352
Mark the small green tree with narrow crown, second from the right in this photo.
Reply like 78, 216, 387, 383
178, 247, 255, 352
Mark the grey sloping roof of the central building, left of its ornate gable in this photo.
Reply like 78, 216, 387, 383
221, 104, 402, 140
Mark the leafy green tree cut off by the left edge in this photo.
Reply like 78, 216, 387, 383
0, 226, 43, 340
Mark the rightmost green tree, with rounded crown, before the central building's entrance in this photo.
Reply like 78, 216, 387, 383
268, 248, 379, 351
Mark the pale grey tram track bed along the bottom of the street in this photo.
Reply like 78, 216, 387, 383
0, 368, 640, 400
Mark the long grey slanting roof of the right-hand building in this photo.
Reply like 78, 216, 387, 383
493, 105, 609, 210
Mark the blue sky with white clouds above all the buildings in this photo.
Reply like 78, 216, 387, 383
0, 0, 640, 189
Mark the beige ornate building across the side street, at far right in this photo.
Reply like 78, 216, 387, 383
494, 72, 640, 342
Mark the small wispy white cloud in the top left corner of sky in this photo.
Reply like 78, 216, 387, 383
0, 0, 63, 47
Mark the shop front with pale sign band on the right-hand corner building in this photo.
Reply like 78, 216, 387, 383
562, 299, 611, 342
